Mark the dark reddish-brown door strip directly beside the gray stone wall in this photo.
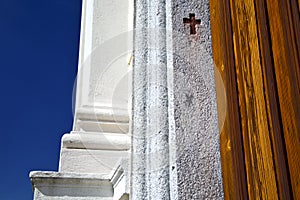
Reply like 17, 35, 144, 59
210, 0, 248, 199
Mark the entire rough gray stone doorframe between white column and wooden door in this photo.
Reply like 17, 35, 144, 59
130, 0, 223, 200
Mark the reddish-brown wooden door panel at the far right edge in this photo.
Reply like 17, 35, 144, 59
267, 0, 300, 199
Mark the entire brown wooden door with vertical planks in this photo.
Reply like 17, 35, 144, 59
210, 0, 300, 199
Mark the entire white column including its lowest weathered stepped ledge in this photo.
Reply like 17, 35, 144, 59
30, 0, 133, 200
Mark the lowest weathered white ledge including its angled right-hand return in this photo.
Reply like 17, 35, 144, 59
29, 159, 130, 200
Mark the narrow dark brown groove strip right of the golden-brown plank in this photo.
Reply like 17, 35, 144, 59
255, 0, 291, 199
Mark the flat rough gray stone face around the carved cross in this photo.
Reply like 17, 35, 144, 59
172, 0, 223, 199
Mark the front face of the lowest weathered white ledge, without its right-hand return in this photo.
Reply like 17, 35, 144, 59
30, 171, 113, 200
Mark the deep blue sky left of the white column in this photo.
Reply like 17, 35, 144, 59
0, 0, 81, 200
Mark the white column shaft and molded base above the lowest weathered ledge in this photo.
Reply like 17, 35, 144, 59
59, 0, 133, 174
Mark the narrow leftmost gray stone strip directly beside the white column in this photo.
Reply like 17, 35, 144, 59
130, 0, 148, 200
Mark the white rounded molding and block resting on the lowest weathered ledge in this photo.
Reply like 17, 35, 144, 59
59, 132, 130, 175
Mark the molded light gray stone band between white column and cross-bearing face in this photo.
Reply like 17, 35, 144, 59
131, 0, 170, 200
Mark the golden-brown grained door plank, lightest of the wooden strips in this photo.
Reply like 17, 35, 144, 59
230, 0, 277, 199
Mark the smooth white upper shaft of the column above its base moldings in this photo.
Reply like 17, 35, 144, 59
75, 0, 133, 114
